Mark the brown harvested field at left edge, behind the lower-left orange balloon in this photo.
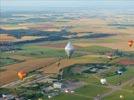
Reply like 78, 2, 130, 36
0, 58, 56, 86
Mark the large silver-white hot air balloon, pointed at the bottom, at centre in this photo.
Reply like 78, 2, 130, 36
65, 42, 74, 58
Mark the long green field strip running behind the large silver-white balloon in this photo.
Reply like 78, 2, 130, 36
16, 46, 82, 57
